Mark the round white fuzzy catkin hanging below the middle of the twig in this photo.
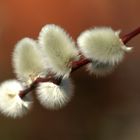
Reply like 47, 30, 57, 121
37, 79, 73, 110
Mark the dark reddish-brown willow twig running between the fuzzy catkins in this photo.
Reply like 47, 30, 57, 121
19, 27, 140, 98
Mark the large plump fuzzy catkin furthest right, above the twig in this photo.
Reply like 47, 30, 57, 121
77, 27, 132, 65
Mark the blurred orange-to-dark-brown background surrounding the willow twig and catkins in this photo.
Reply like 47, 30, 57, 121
0, 0, 140, 140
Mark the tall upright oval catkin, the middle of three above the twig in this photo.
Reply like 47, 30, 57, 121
39, 24, 78, 77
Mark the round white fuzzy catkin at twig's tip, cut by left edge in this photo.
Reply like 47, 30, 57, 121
0, 80, 32, 118
